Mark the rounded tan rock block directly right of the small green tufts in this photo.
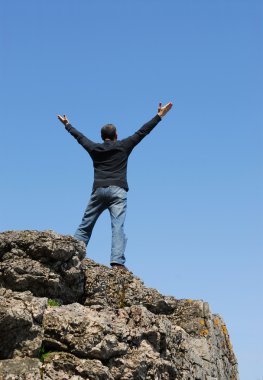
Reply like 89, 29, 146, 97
43, 303, 128, 361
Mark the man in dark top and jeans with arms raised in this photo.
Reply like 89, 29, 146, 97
58, 102, 172, 270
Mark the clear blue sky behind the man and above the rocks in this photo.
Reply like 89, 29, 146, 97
0, 0, 263, 380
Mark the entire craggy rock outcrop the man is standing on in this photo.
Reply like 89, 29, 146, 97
0, 231, 238, 380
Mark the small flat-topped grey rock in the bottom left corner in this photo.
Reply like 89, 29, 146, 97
0, 358, 43, 380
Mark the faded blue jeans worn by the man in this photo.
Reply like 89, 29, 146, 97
74, 186, 127, 265
